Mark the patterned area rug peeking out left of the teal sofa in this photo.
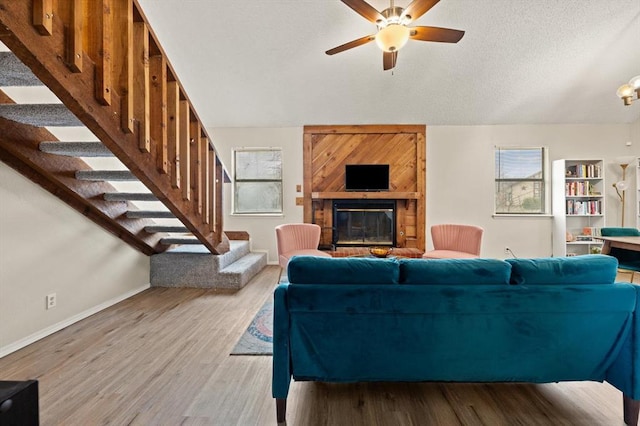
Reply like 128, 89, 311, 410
231, 297, 273, 355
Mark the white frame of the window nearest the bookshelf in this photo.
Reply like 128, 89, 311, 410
493, 146, 551, 217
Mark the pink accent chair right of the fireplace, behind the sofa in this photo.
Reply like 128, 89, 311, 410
422, 224, 484, 259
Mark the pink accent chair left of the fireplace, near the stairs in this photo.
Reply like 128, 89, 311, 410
276, 223, 331, 271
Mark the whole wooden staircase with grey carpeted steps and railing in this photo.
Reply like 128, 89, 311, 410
0, 0, 266, 288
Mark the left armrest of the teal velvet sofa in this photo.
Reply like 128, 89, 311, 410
271, 284, 291, 399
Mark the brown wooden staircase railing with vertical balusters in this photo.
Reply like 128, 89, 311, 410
0, 0, 229, 254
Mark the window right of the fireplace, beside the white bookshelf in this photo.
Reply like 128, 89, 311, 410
495, 147, 548, 214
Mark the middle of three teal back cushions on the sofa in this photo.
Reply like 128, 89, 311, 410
400, 259, 511, 285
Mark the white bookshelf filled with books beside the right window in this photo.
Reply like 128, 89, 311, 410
551, 159, 605, 257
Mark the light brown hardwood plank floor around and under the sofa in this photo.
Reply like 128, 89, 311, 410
0, 266, 623, 426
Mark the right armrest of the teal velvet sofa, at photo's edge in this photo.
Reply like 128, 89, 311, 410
606, 284, 640, 400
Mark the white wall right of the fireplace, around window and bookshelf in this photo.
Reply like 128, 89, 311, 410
427, 121, 640, 258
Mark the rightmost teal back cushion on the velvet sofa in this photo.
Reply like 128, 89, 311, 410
507, 254, 618, 285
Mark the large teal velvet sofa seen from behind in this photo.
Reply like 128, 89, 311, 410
272, 255, 640, 425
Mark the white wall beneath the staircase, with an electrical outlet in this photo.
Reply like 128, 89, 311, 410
0, 162, 149, 357
